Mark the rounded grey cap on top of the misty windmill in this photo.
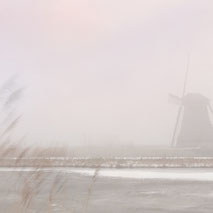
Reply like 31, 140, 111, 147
182, 93, 210, 105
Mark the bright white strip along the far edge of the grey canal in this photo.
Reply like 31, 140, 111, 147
0, 167, 213, 182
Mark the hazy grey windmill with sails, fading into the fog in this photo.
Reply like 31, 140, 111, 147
170, 57, 213, 147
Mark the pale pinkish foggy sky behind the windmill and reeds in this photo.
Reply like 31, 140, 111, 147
0, 0, 213, 146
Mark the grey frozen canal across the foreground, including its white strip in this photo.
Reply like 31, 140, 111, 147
0, 168, 213, 213
